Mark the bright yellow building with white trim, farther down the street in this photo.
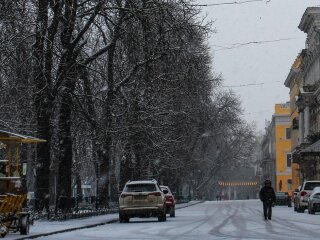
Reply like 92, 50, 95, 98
272, 102, 292, 195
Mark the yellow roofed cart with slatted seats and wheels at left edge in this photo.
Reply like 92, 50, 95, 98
0, 129, 46, 237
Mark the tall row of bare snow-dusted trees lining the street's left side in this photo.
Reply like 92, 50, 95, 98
0, 0, 254, 208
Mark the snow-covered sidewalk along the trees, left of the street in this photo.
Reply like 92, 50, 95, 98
5, 201, 200, 239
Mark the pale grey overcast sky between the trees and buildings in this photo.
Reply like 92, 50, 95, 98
196, 0, 320, 130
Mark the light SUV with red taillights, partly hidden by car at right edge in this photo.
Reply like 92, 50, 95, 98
297, 180, 320, 213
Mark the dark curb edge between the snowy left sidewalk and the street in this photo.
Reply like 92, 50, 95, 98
16, 201, 204, 240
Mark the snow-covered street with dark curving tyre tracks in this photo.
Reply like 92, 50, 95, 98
37, 200, 320, 240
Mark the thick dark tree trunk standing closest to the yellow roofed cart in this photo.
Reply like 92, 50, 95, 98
33, 0, 51, 210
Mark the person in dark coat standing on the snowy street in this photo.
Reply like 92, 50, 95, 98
259, 180, 276, 220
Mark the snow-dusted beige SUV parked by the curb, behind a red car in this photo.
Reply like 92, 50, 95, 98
119, 180, 167, 223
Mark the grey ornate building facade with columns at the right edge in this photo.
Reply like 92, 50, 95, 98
286, 7, 320, 182
